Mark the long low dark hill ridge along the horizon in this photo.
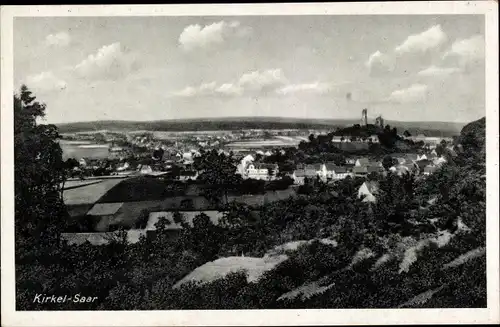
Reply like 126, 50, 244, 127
57, 117, 465, 136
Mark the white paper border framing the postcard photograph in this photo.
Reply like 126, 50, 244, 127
0, 1, 500, 326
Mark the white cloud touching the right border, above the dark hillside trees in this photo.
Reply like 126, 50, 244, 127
443, 35, 485, 66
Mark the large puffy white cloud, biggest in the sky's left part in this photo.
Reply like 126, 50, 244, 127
75, 42, 138, 79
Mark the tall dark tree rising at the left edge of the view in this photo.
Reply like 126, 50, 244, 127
14, 85, 67, 256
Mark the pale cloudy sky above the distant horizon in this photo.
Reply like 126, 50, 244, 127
14, 15, 485, 123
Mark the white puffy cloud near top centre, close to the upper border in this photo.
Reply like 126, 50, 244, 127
179, 21, 251, 51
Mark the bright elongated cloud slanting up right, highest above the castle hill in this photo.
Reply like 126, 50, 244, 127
394, 25, 447, 54
